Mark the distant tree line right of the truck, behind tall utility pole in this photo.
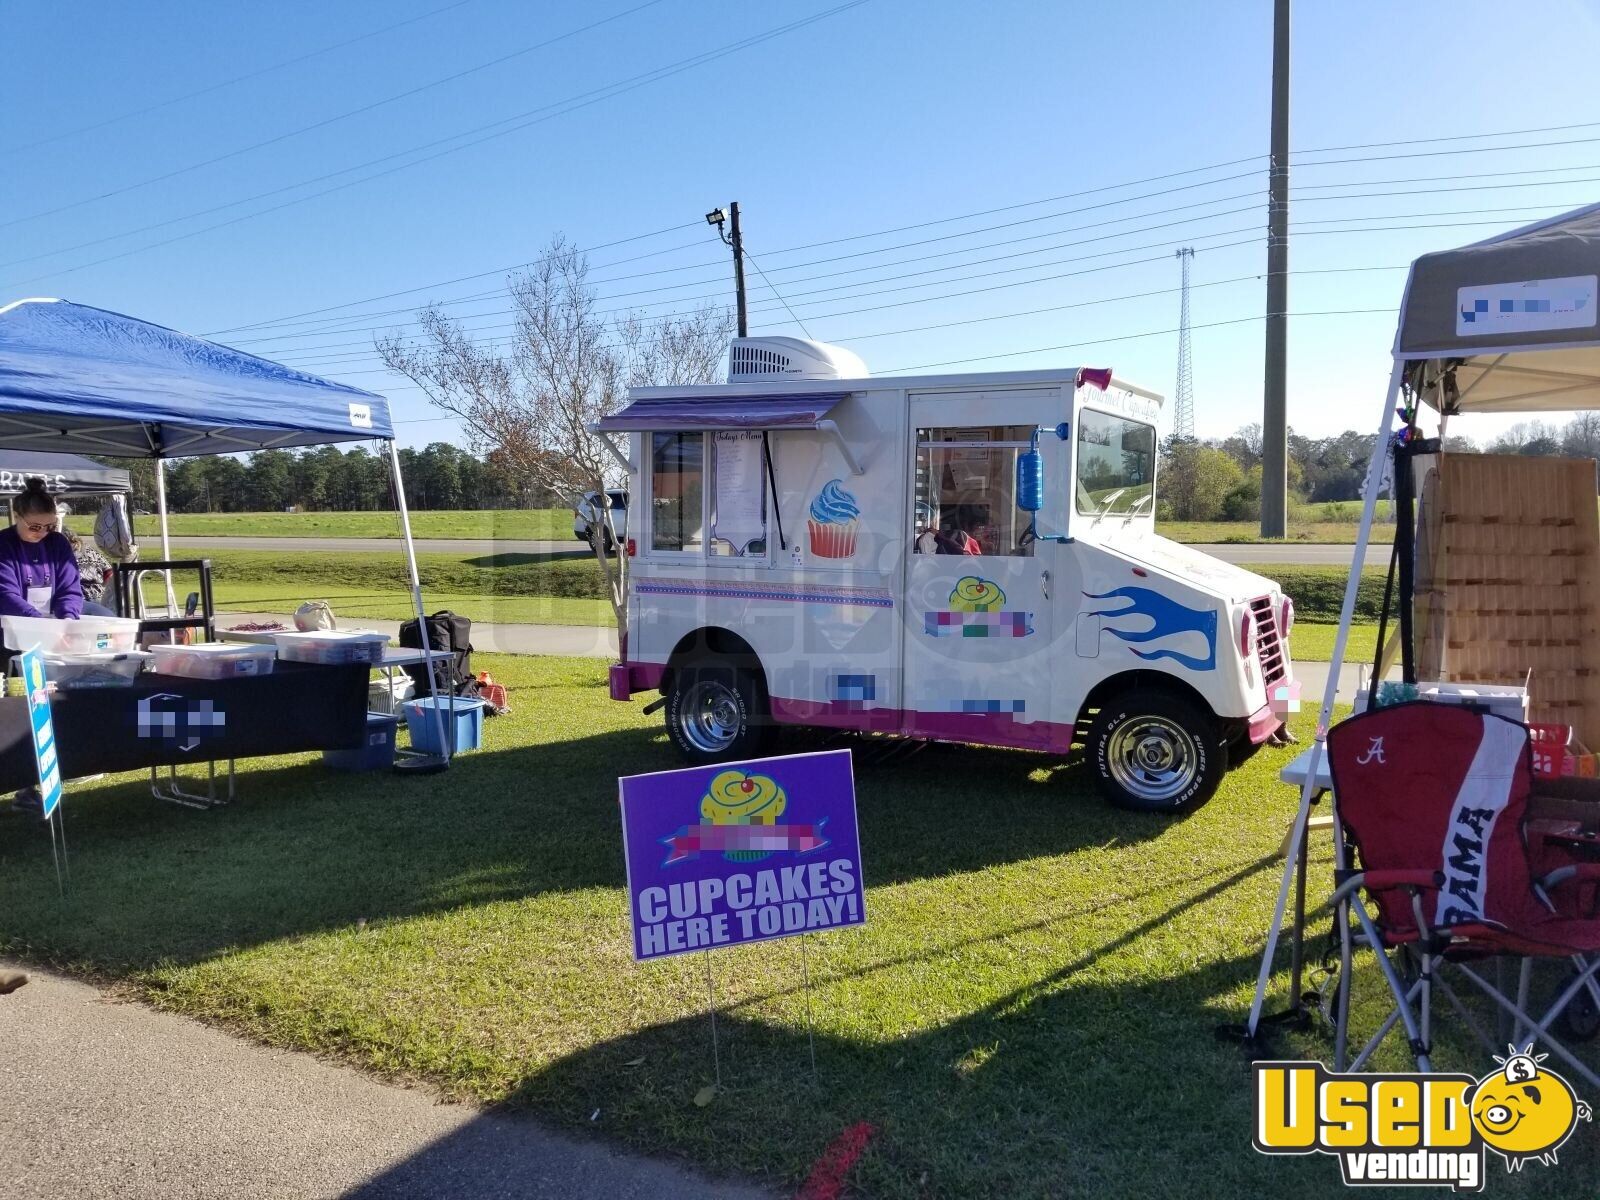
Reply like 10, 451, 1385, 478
1157, 413, 1600, 522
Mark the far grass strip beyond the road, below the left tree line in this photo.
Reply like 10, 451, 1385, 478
72, 509, 578, 546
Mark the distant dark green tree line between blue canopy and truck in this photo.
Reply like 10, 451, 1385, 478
104, 442, 556, 512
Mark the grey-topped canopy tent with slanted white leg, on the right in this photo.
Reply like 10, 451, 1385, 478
1245, 205, 1600, 1070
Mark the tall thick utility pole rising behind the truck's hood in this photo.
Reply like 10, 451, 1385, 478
1261, 0, 1290, 538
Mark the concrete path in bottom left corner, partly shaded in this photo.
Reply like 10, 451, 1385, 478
0, 963, 770, 1200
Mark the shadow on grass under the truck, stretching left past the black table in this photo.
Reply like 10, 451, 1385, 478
0, 713, 1170, 971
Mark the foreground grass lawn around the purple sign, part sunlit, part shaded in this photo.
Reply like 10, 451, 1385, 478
0, 656, 1597, 1200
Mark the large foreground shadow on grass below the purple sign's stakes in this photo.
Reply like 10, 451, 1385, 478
340, 858, 1312, 1197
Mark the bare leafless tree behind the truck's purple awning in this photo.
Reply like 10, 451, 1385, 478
378, 235, 733, 634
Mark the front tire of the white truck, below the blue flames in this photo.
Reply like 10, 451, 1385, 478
1086, 688, 1227, 813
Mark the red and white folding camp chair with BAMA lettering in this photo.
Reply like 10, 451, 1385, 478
1328, 702, 1600, 1088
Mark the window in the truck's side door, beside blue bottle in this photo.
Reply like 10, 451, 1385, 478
912, 426, 1034, 558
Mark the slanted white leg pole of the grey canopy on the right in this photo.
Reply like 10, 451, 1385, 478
1245, 360, 1403, 1043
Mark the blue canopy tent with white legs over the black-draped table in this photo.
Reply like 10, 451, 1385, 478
0, 299, 457, 764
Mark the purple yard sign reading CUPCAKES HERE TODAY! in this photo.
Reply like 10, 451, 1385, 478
618, 750, 867, 962
